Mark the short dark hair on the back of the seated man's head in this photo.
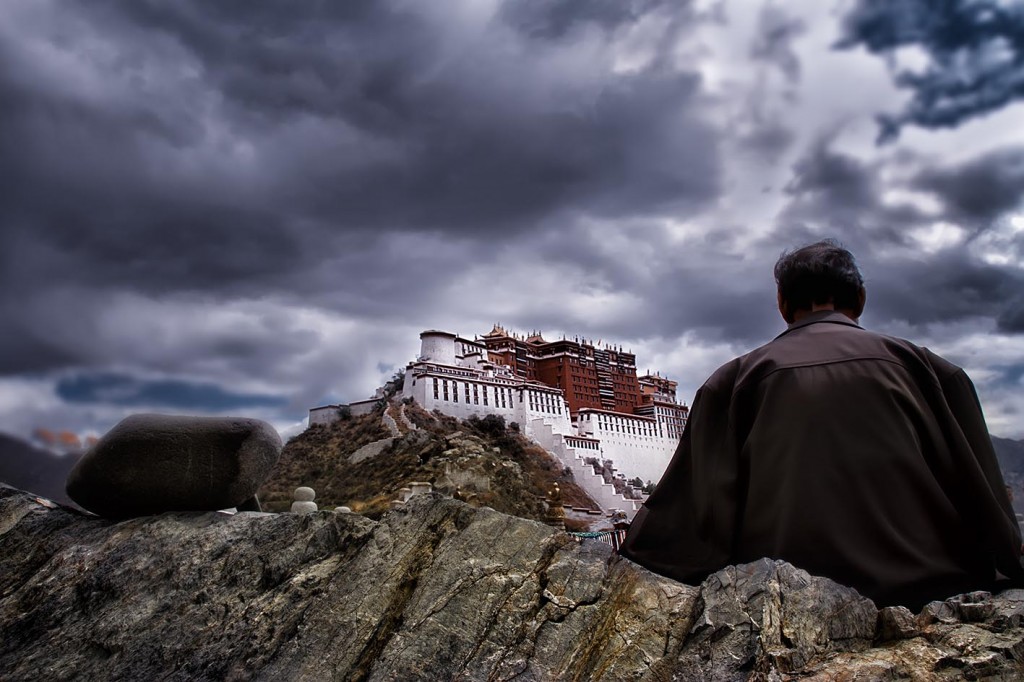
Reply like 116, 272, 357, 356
775, 240, 864, 310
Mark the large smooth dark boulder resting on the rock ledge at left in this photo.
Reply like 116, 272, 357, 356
68, 415, 282, 518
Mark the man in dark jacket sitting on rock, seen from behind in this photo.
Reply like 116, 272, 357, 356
622, 241, 1024, 608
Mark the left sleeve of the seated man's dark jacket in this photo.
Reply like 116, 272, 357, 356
620, 388, 729, 585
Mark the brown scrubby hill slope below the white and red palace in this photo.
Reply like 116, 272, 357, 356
259, 403, 597, 520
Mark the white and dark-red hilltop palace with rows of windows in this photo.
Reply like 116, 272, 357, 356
309, 325, 688, 517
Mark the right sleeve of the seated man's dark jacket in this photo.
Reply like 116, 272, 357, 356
940, 368, 1024, 584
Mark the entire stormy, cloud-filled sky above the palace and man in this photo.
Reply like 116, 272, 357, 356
0, 0, 1024, 438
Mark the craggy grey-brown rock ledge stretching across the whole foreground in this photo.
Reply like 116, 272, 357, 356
0, 487, 1024, 680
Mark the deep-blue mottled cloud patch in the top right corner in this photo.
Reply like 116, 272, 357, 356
840, 0, 1024, 141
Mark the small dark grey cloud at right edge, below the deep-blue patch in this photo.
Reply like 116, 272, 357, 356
914, 147, 1024, 227
